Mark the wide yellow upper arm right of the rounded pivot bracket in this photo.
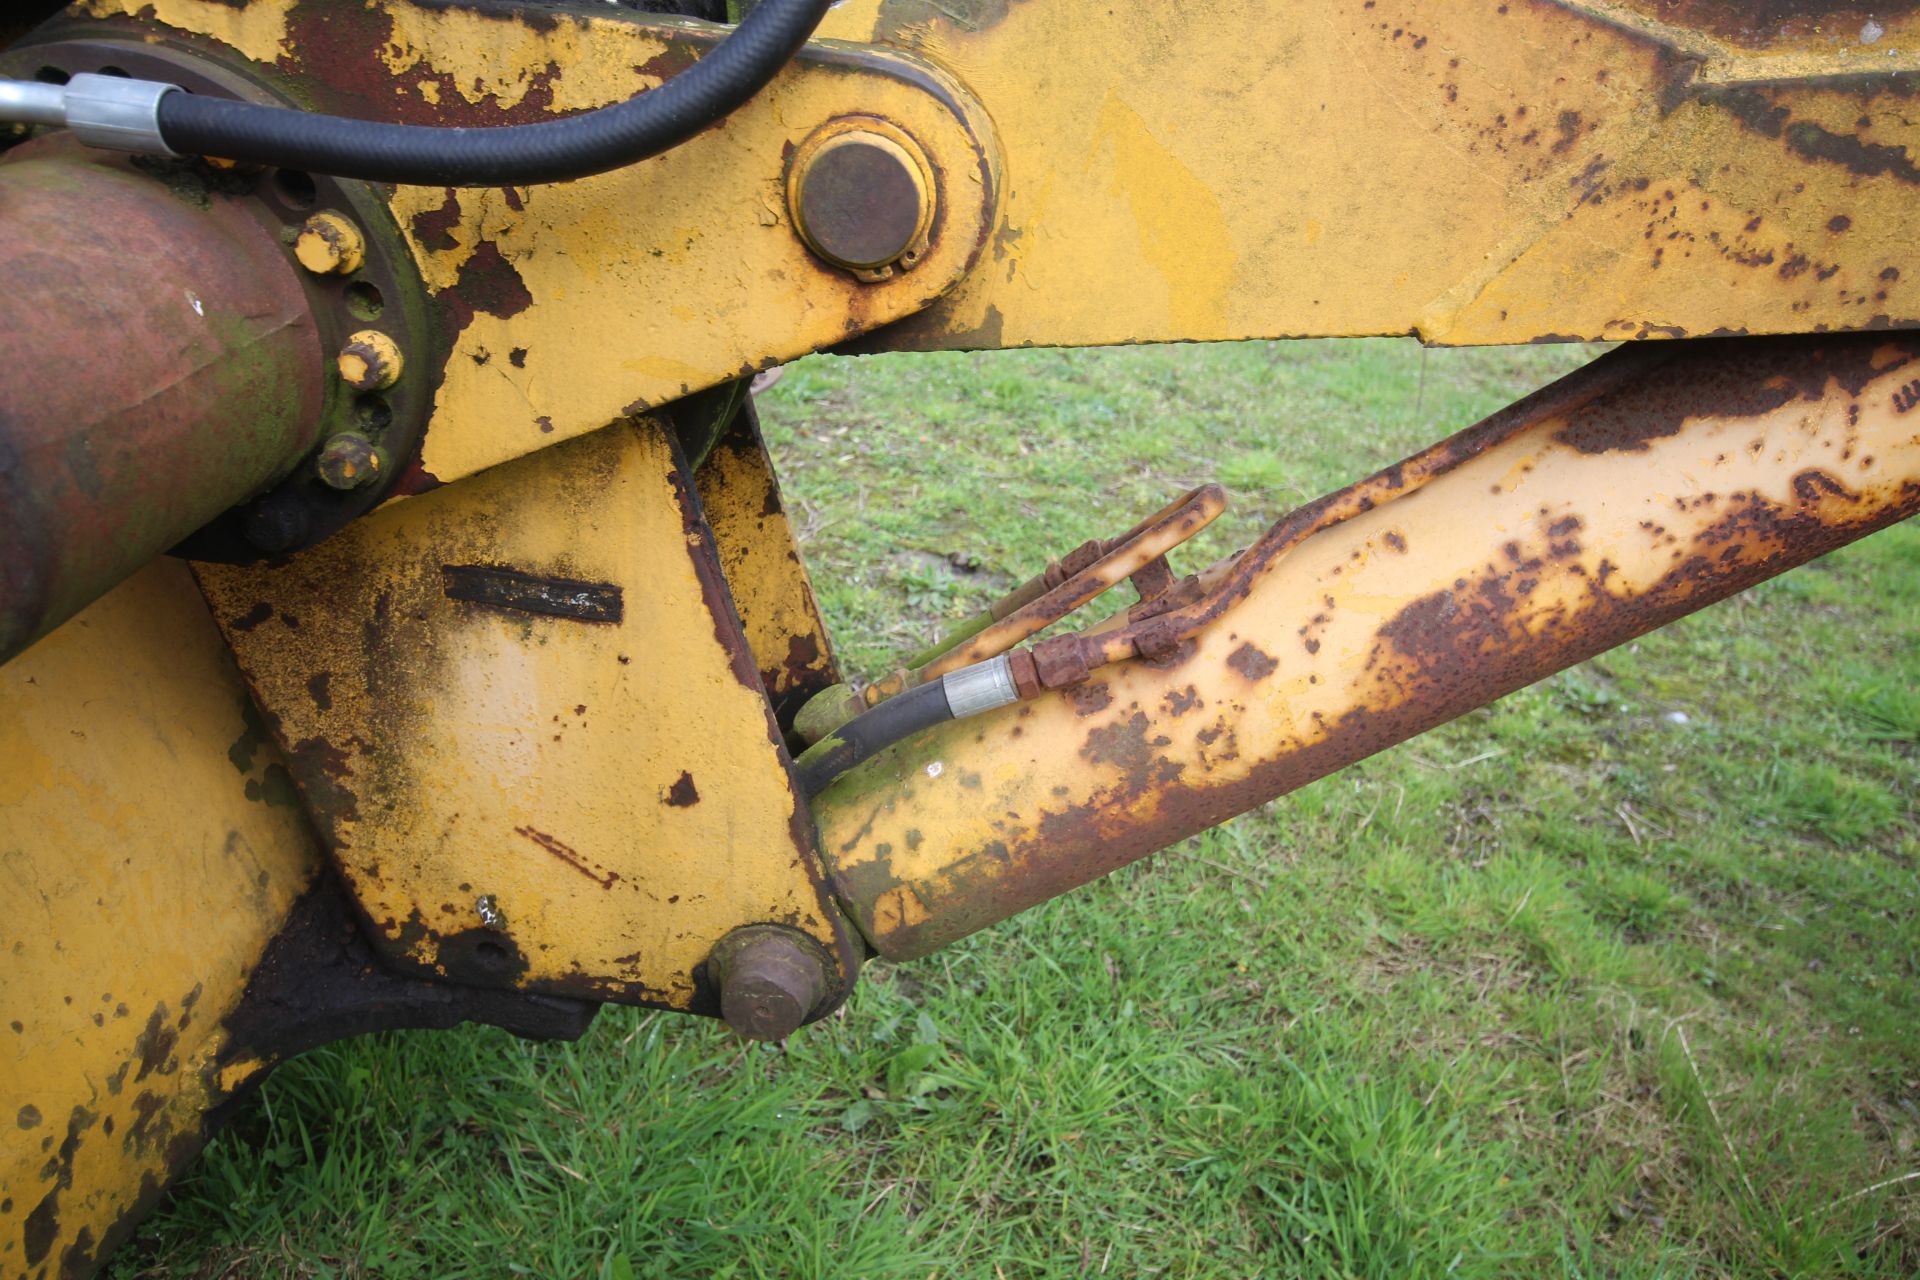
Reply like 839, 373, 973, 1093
822, 0, 1920, 349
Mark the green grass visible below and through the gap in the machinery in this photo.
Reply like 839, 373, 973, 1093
117, 342, 1920, 1280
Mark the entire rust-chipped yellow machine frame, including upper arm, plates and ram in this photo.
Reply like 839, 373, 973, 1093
0, 0, 1920, 1276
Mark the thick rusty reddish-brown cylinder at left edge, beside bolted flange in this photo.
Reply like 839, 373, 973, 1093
0, 138, 324, 662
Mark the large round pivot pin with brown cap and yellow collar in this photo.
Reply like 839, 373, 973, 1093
787, 115, 937, 282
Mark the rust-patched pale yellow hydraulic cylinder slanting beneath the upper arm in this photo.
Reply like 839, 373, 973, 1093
814, 334, 1920, 960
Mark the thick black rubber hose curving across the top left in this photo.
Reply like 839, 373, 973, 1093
157, 0, 831, 186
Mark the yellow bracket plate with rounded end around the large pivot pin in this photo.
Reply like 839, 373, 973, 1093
48, 0, 1000, 493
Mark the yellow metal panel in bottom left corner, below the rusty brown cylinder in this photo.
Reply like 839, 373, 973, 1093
0, 560, 319, 1276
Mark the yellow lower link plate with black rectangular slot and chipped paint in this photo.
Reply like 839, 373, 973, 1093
196, 420, 851, 1007
